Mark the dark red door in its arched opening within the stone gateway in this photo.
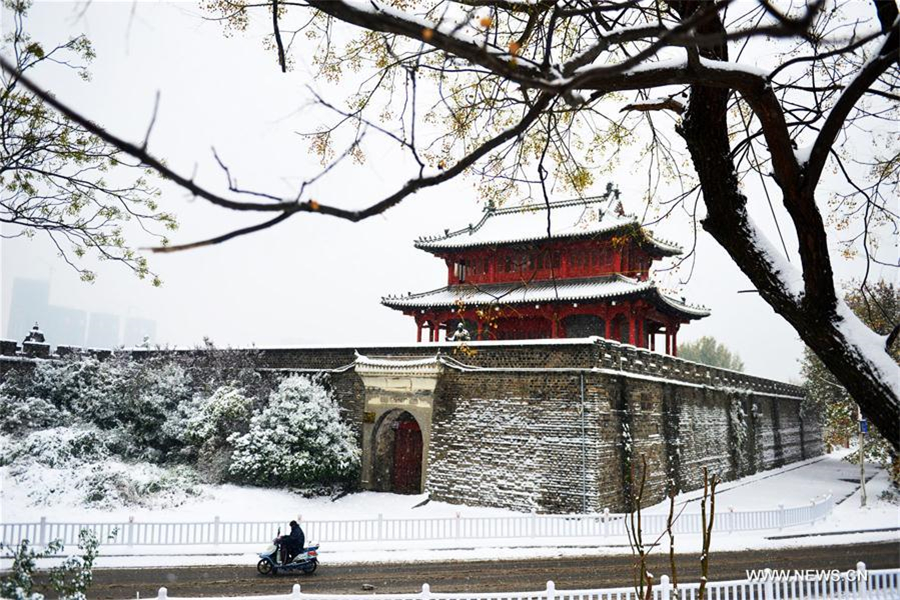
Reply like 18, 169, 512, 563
372, 409, 424, 494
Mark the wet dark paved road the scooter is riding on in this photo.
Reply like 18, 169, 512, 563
79, 542, 900, 600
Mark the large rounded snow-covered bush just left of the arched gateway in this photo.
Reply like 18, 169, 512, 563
229, 376, 359, 487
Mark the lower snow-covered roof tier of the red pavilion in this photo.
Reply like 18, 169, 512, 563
381, 275, 709, 318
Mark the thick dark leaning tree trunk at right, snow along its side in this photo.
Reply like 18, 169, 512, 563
672, 2, 900, 450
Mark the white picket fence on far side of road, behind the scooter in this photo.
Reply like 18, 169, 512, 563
0, 494, 834, 546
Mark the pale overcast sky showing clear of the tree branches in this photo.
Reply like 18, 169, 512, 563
0, 1, 884, 380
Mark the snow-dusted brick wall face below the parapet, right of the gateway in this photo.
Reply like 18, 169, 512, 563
427, 358, 822, 512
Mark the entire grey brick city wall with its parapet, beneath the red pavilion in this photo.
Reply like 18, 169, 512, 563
0, 338, 822, 512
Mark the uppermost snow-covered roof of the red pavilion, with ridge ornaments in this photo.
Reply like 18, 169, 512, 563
415, 193, 682, 255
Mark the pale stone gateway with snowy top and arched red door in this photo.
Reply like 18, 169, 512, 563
355, 356, 441, 494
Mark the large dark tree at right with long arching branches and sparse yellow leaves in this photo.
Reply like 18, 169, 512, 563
3, 0, 900, 447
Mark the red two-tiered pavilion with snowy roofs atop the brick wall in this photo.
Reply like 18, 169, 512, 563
382, 186, 709, 354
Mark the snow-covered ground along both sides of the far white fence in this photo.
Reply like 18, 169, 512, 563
0, 451, 900, 567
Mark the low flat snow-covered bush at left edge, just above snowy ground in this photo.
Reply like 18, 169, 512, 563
0, 427, 109, 468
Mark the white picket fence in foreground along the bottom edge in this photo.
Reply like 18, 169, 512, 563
151, 562, 900, 600
